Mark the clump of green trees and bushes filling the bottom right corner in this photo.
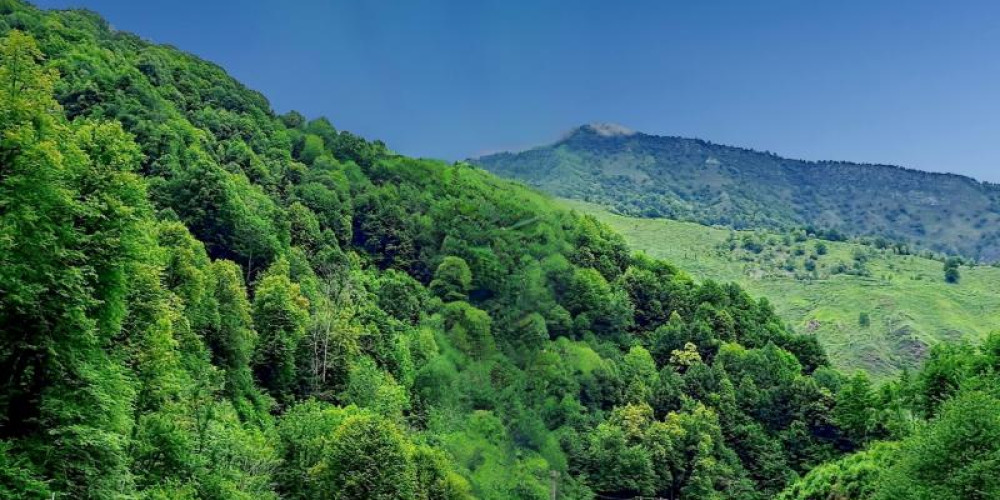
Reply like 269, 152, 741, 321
779, 334, 1000, 500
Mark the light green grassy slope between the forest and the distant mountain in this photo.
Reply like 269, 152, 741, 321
562, 200, 1000, 377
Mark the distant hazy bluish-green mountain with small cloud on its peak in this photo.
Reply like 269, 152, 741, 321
471, 124, 1000, 261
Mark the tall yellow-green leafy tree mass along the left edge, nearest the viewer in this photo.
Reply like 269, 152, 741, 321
0, 31, 146, 498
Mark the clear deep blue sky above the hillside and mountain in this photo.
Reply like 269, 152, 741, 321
31, 0, 1000, 182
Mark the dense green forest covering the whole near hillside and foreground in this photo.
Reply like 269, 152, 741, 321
0, 0, 1000, 500
